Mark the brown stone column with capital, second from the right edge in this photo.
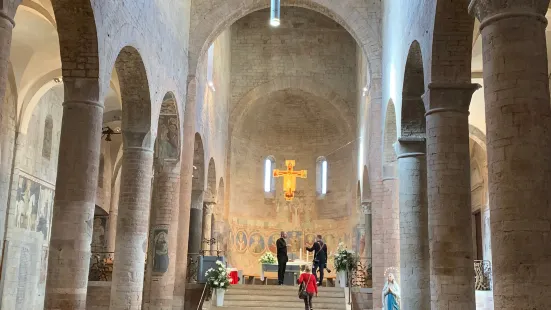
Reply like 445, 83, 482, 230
423, 83, 479, 310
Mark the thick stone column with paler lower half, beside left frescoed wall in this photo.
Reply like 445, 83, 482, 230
44, 79, 103, 310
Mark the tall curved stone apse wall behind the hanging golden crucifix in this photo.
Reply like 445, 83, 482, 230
228, 7, 357, 274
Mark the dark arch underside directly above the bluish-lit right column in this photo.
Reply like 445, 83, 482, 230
400, 41, 426, 138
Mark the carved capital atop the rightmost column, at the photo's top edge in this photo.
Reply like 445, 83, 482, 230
469, 0, 549, 29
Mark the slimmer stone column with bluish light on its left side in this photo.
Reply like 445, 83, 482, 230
396, 138, 430, 310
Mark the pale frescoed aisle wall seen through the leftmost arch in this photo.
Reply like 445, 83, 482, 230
2, 86, 63, 309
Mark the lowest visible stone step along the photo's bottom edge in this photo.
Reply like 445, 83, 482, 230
220, 297, 346, 310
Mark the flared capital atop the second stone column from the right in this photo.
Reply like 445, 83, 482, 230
422, 83, 481, 116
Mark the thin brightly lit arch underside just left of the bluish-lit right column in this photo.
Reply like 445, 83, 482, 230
383, 100, 398, 177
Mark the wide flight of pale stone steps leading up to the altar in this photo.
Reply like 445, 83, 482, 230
212, 285, 346, 310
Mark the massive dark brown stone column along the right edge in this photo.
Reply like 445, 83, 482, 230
470, 0, 551, 310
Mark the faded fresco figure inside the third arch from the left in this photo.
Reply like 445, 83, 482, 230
155, 115, 180, 159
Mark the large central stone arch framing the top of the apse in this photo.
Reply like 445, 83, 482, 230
189, 0, 381, 85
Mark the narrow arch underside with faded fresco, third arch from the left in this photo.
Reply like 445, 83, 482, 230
155, 92, 181, 163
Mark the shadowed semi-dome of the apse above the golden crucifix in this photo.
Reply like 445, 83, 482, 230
232, 89, 346, 143
